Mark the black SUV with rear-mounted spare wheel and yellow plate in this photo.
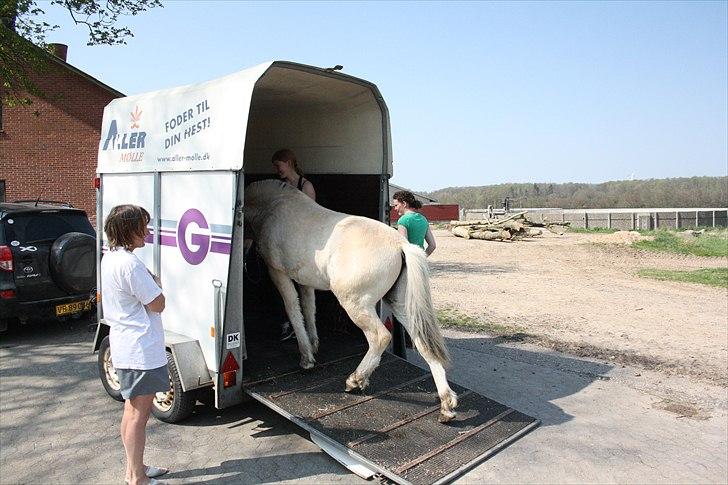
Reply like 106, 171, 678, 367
0, 201, 96, 332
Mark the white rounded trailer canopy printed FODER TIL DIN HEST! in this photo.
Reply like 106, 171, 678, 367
98, 61, 392, 175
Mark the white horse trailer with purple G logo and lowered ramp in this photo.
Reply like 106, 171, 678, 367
94, 62, 537, 483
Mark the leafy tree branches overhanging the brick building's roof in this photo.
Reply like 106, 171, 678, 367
0, 0, 162, 106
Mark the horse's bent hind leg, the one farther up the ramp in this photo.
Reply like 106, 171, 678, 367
341, 302, 392, 392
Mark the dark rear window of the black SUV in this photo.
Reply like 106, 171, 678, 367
3, 213, 96, 243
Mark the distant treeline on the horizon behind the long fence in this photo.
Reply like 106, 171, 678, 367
425, 177, 728, 209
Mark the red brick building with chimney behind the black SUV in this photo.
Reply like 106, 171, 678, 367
0, 44, 123, 221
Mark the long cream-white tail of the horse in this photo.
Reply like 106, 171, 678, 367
388, 242, 450, 366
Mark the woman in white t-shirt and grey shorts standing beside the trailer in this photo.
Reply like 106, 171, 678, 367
101, 205, 169, 485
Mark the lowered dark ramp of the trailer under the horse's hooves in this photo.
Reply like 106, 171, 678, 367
243, 346, 538, 484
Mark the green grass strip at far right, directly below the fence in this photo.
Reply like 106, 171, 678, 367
632, 230, 728, 257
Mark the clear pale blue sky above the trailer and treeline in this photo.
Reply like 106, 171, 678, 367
39, 1, 728, 190
